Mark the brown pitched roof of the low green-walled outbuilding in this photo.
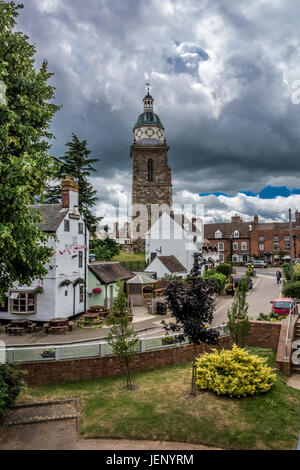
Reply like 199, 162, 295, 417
89, 261, 134, 284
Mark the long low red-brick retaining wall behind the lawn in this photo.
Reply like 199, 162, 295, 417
21, 322, 280, 385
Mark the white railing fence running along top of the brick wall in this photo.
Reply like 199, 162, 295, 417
0, 325, 228, 363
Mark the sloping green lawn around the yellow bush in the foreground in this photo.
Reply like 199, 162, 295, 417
19, 348, 300, 449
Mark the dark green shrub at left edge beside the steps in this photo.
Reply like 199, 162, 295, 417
0, 364, 24, 414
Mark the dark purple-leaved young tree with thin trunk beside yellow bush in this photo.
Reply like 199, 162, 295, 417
162, 255, 219, 395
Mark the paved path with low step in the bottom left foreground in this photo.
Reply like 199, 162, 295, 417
0, 399, 220, 451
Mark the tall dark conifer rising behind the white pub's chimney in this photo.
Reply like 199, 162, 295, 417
45, 133, 101, 233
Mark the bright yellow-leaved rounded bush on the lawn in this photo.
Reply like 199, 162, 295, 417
196, 344, 276, 398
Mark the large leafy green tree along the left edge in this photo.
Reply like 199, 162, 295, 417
0, 0, 59, 297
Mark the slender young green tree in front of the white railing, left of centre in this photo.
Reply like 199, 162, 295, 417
107, 281, 139, 390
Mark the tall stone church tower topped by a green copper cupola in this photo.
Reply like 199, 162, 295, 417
130, 84, 172, 246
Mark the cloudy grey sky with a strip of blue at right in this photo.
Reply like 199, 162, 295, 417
18, 0, 300, 226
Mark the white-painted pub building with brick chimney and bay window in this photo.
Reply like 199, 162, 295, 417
0, 177, 89, 322
